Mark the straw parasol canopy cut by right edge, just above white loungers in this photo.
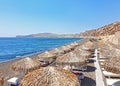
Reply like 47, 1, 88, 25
104, 57, 120, 74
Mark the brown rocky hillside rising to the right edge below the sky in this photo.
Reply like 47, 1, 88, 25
79, 21, 120, 36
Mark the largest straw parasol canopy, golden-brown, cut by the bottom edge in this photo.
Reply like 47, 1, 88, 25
19, 67, 80, 86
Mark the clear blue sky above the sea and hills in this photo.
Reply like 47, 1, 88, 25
0, 0, 120, 37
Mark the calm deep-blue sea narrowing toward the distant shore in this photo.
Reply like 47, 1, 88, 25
0, 38, 82, 62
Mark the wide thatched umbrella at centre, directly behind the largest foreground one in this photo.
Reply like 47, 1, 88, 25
56, 52, 86, 68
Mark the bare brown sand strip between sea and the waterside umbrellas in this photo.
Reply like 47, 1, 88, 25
0, 39, 88, 86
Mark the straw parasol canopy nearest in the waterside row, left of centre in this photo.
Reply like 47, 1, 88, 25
11, 57, 40, 73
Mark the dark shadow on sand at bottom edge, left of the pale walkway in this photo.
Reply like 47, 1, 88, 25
81, 77, 96, 86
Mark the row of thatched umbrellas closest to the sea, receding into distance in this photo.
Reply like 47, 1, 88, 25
11, 42, 80, 72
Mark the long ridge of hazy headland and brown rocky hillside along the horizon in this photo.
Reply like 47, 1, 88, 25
16, 21, 120, 38
